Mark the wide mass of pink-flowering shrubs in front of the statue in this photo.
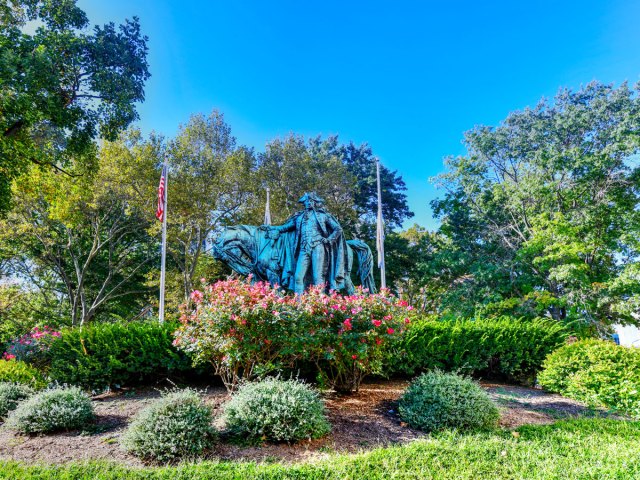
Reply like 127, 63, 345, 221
174, 280, 411, 391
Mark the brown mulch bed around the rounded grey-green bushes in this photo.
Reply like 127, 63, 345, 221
0, 380, 616, 466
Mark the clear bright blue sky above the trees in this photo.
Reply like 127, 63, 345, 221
79, 0, 640, 228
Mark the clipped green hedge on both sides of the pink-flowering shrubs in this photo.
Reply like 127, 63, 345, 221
21, 317, 567, 390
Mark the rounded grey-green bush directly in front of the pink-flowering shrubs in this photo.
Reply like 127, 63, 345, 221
224, 378, 331, 442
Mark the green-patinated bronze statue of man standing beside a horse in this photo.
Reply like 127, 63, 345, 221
213, 192, 375, 294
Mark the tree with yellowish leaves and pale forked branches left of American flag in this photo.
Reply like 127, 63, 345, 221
0, 152, 157, 325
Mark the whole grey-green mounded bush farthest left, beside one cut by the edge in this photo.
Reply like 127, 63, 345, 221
6, 387, 95, 433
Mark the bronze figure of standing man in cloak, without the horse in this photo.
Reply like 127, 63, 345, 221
260, 192, 348, 294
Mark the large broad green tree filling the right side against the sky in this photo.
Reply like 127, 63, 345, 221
418, 82, 640, 330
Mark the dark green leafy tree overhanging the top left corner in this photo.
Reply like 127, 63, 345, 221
0, 0, 149, 214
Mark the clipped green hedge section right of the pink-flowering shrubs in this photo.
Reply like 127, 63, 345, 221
386, 317, 567, 382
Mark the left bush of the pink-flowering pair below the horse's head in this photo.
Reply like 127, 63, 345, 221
174, 280, 296, 390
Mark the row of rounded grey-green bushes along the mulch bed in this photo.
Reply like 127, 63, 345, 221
0, 371, 499, 462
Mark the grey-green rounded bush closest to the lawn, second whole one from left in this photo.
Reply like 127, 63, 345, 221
122, 390, 216, 462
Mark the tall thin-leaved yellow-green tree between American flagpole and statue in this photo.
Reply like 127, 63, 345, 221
167, 110, 259, 299
